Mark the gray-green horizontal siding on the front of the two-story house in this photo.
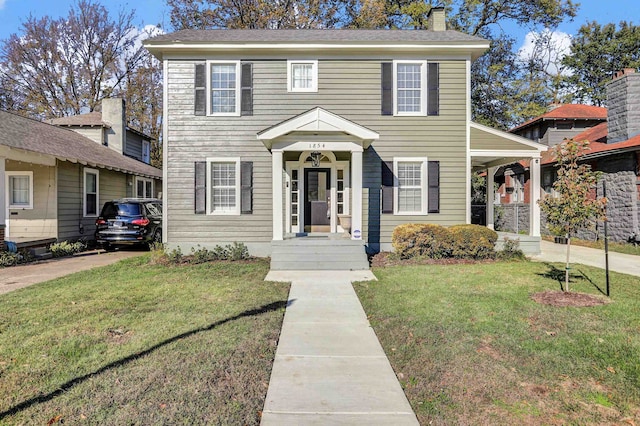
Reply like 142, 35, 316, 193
165, 60, 466, 248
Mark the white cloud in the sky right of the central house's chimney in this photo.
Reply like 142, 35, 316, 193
518, 29, 571, 75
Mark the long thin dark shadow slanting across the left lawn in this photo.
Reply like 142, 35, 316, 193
0, 300, 294, 420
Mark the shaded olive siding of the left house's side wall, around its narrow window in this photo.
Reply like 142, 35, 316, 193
58, 161, 129, 240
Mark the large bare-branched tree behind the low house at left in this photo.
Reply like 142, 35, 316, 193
0, 0, 162, 166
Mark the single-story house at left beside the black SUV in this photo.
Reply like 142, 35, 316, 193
0, 111, 162, 250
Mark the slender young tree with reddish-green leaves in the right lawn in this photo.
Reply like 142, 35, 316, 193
540, 139, 607, 292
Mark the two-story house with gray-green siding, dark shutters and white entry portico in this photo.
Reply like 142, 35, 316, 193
145, 8, 546, 267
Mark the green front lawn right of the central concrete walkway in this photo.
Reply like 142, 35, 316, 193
355, 262, 640, 425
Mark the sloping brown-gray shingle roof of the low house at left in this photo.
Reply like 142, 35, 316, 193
0, 111, 162, 179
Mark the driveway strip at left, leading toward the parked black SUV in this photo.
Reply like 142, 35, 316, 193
0, 250, 145, 294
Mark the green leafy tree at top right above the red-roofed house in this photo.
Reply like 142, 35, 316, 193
563, 21, 640, 106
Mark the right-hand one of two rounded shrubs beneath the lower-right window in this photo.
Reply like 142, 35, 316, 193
449, 225, 498, 259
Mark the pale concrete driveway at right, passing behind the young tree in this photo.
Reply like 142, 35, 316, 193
532, 240, 640, 277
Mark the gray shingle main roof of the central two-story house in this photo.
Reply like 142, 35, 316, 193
145, 29, 488, 45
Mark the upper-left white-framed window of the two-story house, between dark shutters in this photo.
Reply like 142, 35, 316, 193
209, 61, 240, 115
